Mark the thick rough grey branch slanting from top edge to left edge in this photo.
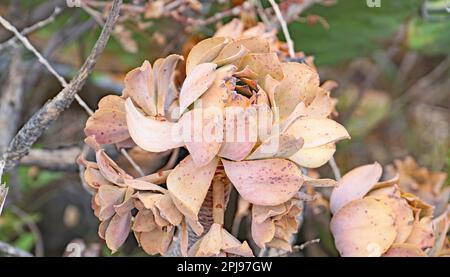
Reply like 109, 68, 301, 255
3, 0, 122, 170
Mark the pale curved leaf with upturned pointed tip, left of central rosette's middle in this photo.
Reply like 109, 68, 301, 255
125, 99, 184, 152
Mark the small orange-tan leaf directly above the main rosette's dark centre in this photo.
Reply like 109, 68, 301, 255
238, 52, 284, 82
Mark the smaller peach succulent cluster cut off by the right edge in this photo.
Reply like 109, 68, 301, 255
330, 157, 450, 257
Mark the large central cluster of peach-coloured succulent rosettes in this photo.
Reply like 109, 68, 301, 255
80, 20, 349, 256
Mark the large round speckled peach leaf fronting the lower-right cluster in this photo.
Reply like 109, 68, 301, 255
330, 198, 397, 257
